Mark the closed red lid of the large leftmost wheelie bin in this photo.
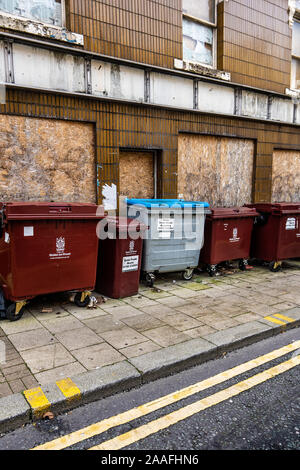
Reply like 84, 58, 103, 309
0, 202, 104, 220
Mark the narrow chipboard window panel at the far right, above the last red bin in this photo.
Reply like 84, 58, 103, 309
272, 150, 300, 202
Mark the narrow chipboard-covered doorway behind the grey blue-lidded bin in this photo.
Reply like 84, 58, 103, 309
119, 150, 157, 198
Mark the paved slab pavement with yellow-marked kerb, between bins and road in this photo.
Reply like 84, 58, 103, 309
0, 261, 300, 433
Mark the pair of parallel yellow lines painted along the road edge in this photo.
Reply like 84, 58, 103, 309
33, 341, 300, 450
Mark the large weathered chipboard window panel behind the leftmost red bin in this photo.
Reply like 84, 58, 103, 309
0, 115, 97, 203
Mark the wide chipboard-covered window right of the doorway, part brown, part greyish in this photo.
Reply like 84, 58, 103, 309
178, 134, 254, 207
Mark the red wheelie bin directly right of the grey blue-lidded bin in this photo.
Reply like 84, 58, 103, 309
199, 207, 258, 276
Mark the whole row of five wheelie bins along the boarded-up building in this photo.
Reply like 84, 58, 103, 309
0, 199, 300, 321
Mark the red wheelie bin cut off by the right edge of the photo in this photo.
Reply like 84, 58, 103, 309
247, 202, 300, 272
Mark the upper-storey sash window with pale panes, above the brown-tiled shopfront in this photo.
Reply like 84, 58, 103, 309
182, 0, 217, 67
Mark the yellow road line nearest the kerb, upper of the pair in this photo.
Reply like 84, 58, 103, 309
33, 341, 300, 450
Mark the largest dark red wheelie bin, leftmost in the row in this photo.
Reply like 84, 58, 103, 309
0, 202, 104, 321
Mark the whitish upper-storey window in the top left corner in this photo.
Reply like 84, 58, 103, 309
0, 0, 65, 26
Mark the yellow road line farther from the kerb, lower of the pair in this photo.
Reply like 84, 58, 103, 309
89, 355, 300, 451
